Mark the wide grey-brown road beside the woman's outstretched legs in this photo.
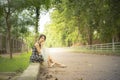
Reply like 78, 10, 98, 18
39, 48, 120, 80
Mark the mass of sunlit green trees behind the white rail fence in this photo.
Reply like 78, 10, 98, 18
46, 0, 120, 46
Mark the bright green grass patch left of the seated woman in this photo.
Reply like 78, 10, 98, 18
0, 53, 30, 72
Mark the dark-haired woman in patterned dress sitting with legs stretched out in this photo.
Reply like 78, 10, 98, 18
30, 34, 66, 67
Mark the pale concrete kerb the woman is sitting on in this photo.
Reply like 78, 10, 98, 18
17, 63, 40, 80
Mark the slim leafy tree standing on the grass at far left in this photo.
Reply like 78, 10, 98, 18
0, 0, 31, 58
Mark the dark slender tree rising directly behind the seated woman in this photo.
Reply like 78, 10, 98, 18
26, 0, 50, 41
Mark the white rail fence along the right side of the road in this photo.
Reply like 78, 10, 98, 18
79, 42, 120, 53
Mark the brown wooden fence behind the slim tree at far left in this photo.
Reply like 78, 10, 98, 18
0, 34, 28, 54
